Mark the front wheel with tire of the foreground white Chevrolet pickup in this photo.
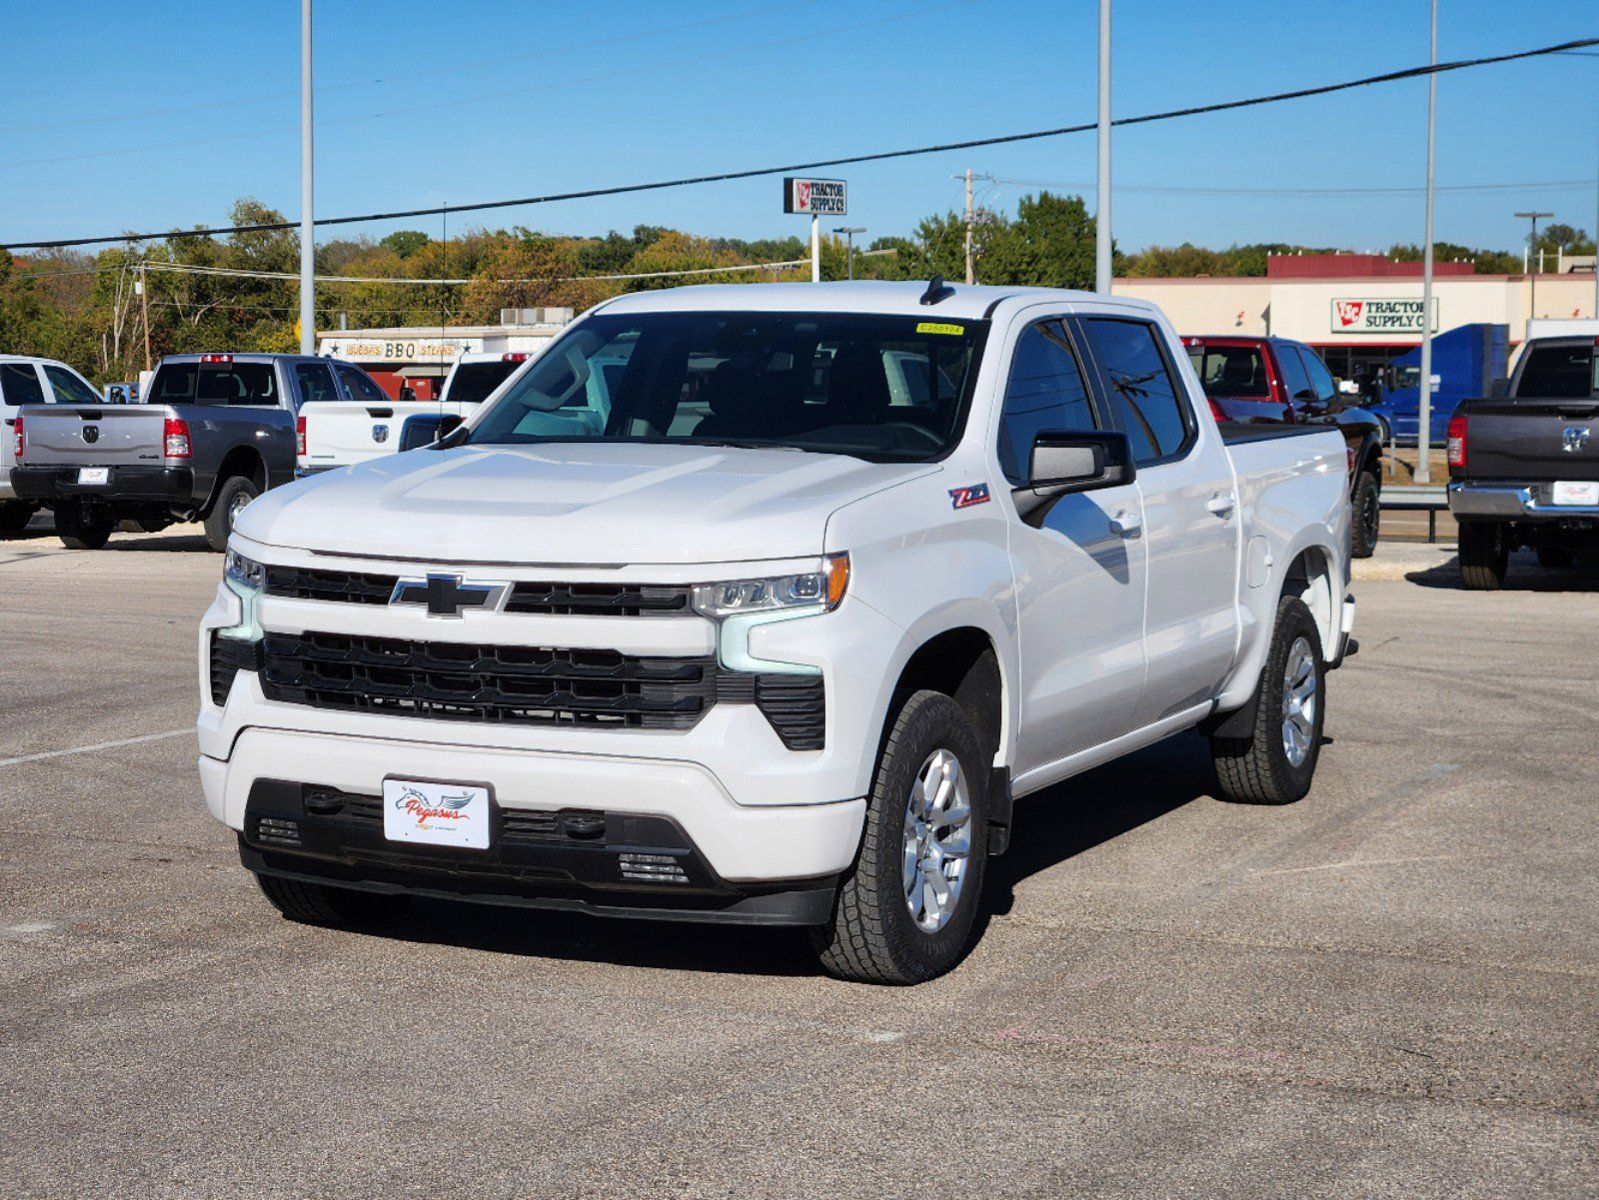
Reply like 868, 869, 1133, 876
812, 691, 990, 984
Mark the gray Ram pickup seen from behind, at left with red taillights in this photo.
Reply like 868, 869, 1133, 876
11, 354, 362, 550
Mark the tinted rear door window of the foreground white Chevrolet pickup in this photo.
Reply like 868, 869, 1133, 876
1083, 317, 1191, 464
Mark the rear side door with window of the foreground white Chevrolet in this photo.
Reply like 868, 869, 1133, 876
1078, 315, 1241, 728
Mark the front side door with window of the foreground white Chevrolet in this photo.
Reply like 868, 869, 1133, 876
998, 314, 1145, 774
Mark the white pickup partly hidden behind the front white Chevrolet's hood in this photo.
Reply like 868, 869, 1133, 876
294, 350, 532, 477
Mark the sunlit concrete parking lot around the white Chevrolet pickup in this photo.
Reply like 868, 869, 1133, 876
0, 528, 1599, 1198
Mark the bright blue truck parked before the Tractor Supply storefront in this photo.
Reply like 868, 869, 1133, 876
1361, 325, 1509, 446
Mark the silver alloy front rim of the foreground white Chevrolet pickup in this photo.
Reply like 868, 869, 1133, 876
900, 747, 972, 933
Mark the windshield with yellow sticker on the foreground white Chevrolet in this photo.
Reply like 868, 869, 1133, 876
467, 312, 987, 462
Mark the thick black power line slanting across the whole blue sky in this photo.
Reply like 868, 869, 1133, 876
8, 37, 1599, 250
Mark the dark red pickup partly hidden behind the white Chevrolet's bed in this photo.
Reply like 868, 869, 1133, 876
1183, 336, 1383, 558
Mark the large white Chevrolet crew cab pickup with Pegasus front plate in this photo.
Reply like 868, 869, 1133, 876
198, 280, 1354, 982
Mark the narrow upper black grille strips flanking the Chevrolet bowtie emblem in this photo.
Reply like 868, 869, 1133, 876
267, 566, 689, 616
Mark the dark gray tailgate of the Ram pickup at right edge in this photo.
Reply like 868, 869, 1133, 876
1455, 397, 1599, 483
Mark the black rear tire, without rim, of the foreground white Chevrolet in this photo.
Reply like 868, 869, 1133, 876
1210, 595, 1327, 805
